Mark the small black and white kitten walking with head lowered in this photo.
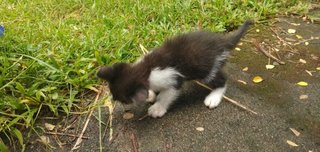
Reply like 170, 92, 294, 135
98, 21, 252, 118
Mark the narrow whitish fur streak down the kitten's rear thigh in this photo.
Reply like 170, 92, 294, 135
204, 51, 229, 83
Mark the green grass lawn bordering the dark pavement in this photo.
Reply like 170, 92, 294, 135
0, 0, 309, 151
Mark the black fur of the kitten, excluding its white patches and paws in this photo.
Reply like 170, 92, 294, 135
98, 21, 251, 103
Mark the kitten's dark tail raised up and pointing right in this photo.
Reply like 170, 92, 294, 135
226, 20, 254, 49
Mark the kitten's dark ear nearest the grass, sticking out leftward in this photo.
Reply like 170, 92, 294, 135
97, 63, 126, 82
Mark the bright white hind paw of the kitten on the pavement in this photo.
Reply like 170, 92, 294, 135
204, 86, 227, 108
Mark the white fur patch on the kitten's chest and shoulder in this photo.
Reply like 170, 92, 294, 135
149, 67, 183, 91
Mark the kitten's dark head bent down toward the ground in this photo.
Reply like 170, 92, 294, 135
97, 63, 148, 104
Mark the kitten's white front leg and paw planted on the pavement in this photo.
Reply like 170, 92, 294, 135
148, 88, 180, 118
